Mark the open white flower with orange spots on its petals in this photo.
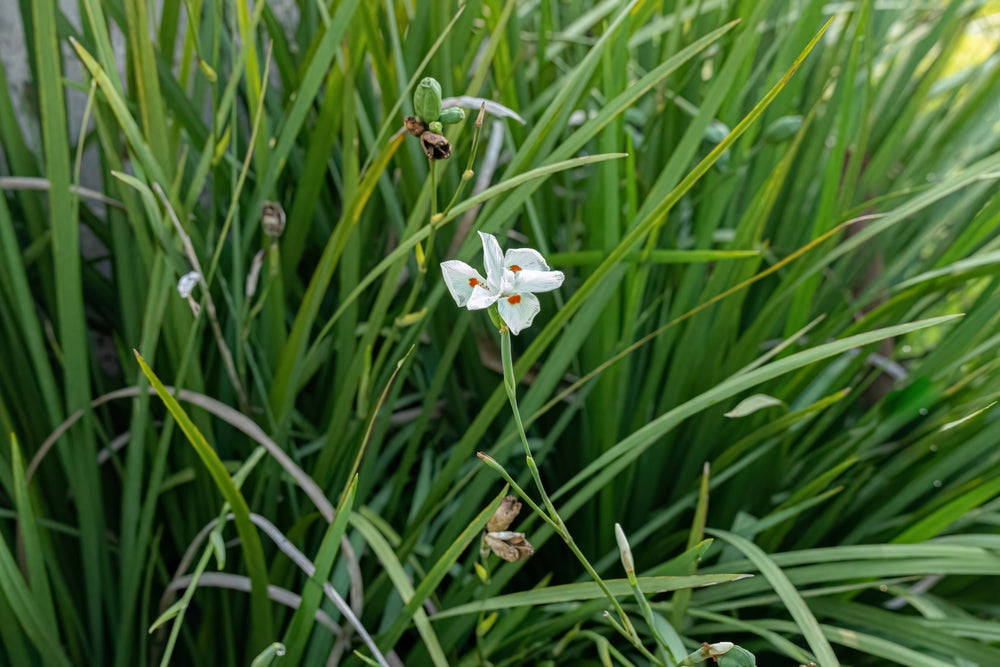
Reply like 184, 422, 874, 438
441, 232, 564, 335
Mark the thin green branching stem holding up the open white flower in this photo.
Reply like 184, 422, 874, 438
500, 327, 658, 662
